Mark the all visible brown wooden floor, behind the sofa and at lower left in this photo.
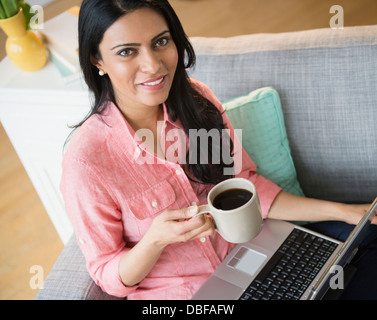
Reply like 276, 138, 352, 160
0, 0, 377, 300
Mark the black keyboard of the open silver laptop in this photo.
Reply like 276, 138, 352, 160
240, 228, 338, 300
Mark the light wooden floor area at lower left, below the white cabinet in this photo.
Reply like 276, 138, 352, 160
0, 125, 63, 299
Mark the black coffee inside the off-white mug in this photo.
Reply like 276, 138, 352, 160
212, 189, 253, 210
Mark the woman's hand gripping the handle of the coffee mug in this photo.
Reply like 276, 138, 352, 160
145, 206, 215, 247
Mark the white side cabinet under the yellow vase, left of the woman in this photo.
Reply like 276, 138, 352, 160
0, 58, 90, 244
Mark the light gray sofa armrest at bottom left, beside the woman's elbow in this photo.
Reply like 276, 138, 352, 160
36, 235, 119, 300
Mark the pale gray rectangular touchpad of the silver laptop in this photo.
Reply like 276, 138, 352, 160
228, 247, 267, 276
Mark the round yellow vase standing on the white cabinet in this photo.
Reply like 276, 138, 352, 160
0, 9, 47, 72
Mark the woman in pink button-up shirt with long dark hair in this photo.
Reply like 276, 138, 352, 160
61, 0, 374, 299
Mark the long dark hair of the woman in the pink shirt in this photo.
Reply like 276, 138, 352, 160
75, 0, 233, 184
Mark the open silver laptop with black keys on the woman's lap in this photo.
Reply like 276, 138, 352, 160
193, 198, 377, 300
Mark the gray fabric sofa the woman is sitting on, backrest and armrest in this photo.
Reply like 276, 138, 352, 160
37, 25, 377, 299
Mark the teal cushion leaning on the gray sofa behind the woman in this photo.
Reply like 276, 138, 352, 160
223, 87, 304, 196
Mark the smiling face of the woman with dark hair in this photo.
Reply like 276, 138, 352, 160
93, 8, 178, 118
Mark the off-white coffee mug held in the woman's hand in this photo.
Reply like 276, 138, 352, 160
194, 178, 263, 243
